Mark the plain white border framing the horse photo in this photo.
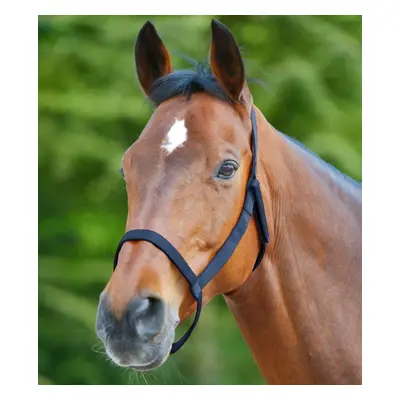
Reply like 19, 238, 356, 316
0, 0, 400, 400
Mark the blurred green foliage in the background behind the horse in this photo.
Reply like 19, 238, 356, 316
39, 16, 361, 384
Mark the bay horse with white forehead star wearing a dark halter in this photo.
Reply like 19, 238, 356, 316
96, 19, 362, 385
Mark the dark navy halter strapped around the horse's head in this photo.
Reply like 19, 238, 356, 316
114, 108, 269, 354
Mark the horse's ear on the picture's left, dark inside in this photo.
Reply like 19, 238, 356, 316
135, 21, 172, 96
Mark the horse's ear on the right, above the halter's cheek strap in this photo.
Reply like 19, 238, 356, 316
210, 19, 247, 102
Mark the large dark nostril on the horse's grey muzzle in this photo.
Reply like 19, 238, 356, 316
127, 297, 165, 340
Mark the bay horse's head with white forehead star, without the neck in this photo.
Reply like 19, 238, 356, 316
97, 20, 263, 370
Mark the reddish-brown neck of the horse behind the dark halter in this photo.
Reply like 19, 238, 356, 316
225, 106, 361, 384
